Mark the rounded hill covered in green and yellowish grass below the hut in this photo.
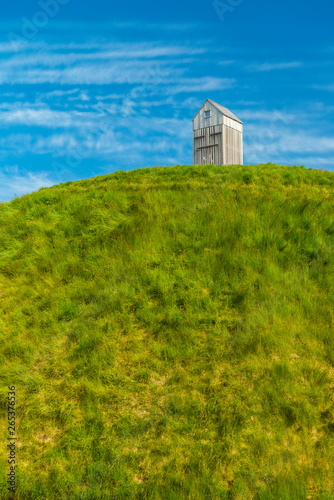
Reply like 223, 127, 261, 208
0, 165, 334, 500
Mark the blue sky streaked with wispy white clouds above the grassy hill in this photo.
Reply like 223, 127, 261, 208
0, 0, 334, 201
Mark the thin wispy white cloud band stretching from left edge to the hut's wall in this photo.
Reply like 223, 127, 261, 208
0, 114, 192, 158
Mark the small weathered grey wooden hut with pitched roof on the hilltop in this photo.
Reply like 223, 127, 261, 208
193, 101, 243, 165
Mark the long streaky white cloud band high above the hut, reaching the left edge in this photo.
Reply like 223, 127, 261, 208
0, 42, 207, 86
